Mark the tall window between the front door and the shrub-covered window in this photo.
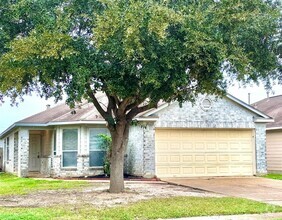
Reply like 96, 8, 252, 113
63, 129, 78, 167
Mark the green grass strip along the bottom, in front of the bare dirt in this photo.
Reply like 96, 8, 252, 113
0, 197, 282, 220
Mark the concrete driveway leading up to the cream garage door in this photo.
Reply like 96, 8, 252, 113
162, 177, 282, 206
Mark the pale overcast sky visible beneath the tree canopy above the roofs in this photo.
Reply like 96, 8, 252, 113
0, 82, 282, 133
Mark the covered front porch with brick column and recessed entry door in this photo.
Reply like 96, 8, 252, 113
4, 128, 56, 177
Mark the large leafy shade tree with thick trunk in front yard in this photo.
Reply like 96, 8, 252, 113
0, 0, 281, 192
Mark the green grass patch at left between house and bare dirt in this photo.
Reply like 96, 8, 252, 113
0, 173, 89, 196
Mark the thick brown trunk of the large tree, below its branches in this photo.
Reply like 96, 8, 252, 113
110, 122, 129, 193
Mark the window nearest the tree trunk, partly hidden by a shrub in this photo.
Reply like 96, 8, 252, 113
89, 128, 108, 167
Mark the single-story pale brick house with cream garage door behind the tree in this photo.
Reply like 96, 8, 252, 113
0, 94, 273, 177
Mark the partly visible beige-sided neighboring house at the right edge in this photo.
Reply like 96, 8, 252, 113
253, 95, 282, 173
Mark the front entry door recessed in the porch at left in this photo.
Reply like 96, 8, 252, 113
28, 135, 41, 171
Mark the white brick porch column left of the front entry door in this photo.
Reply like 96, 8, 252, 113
18, 129, 29, 177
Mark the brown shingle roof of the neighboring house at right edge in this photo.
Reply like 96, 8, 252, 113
253, 95, 282, 128
